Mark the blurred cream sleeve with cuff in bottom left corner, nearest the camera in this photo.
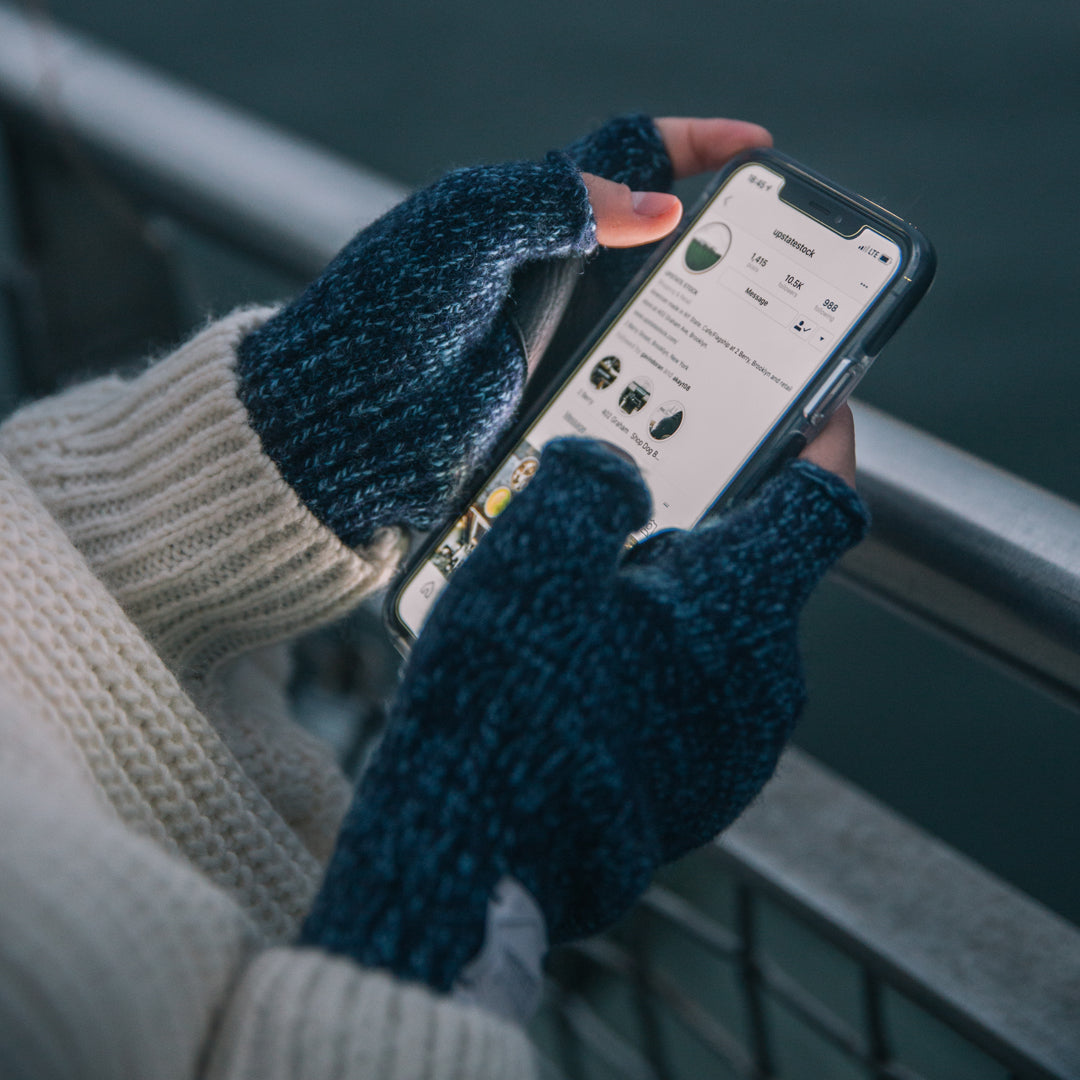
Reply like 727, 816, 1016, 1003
0, 701, 535, 1080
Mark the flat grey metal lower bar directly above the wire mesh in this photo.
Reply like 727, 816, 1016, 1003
712, 750, 1080, 1080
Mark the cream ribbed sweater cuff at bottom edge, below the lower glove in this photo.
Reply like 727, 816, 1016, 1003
207, 948, 536, 1080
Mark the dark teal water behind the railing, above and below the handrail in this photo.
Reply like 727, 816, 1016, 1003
8, 0, 1080, 921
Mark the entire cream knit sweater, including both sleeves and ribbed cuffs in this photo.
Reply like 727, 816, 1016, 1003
0, 310, 535, 1080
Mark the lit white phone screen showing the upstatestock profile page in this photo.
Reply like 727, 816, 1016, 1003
396, 163, 902, 636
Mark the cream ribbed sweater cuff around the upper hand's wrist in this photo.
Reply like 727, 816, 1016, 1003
0, 309, 405, 676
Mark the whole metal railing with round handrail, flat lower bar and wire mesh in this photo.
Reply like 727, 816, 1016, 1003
0, 4, 1080, 1078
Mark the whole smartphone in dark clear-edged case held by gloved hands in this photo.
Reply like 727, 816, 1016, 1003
386, 143, 935, 650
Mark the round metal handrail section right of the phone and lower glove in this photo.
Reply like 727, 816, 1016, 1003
839, 404, 1080, 708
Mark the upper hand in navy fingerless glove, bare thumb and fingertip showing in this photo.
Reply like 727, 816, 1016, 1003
237, 117, 768, 545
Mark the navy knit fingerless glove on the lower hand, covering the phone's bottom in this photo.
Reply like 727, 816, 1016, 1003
302, 440, 866, 989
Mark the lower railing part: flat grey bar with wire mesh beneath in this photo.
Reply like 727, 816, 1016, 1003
548, 751, 1080, 1080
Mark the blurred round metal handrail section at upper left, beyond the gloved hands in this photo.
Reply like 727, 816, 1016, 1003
0, 4, 407, 276
